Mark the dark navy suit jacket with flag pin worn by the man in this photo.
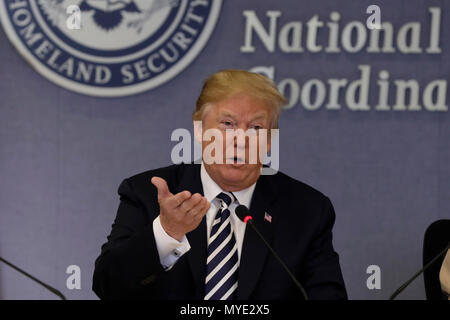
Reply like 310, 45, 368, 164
93, 164, 347, 300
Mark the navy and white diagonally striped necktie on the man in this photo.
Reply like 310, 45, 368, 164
205, 192, 238, 300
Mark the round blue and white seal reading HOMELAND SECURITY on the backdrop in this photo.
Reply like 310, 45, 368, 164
0, 0, 222, 97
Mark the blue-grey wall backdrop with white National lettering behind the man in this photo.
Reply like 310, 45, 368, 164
0, 0, 450, 299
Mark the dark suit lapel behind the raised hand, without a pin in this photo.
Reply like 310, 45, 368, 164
174, 164, 206, 299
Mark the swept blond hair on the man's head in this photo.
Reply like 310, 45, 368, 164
192, 69, 286, 128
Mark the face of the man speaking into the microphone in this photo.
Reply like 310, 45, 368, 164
198, 94, 271, 192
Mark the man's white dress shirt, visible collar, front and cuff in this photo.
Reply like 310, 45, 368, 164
153, 162, 256, 270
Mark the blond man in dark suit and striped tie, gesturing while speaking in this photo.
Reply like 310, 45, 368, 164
93, 70, 347, 300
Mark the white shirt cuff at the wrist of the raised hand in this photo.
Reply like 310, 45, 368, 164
153, 216, 191, 271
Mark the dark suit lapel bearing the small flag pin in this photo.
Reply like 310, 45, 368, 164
237, 176, 277, 300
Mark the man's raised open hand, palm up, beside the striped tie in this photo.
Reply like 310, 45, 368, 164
151, 177, 211, 241
